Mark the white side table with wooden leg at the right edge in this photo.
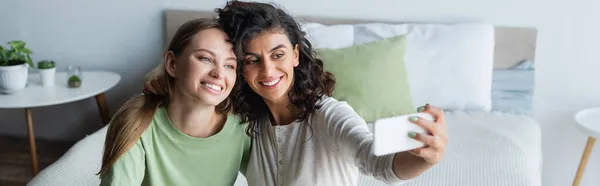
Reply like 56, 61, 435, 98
573, 107, 600, 186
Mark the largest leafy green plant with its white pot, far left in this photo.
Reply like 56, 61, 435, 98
0, 40, 34, 94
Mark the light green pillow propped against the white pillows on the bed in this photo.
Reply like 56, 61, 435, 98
316, 36, 415, 122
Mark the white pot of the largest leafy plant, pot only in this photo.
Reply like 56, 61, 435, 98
0, 63, 29, 94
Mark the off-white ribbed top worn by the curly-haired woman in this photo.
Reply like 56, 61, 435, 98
246, 97, 404, 186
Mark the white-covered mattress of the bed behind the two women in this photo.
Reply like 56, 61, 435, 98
28, 112, 542, 186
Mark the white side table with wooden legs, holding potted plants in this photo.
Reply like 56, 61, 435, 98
0, 71, 121, 176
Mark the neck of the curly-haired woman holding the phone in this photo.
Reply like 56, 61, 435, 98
264, 96, 298, 125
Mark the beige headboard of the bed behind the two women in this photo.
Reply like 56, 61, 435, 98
163, 10, 537, 69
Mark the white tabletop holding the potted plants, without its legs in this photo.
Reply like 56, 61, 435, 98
0, 71, 121, 108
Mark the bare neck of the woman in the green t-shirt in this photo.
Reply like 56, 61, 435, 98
167, 93, 225, 138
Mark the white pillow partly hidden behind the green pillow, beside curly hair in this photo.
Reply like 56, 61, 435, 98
300, 22, 354, 48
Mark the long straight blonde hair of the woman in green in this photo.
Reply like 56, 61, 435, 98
98, 18, 237, 176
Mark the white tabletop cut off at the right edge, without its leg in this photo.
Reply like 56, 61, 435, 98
575, 107, 600, 138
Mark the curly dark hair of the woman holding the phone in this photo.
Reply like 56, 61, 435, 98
215, 1, 335, 136
